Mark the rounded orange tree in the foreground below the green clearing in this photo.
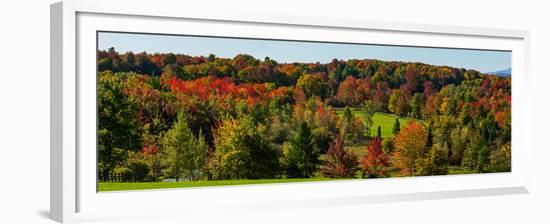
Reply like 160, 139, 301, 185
392, 121, 428, 176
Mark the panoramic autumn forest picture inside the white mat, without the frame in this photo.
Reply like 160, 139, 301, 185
97, 31, 512, 192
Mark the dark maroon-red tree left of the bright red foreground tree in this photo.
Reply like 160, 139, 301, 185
321, 136, 358, 178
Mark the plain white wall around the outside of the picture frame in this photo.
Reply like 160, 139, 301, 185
0, 0, 550, 224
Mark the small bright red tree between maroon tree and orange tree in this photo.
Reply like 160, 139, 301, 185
361, 138, 390, 178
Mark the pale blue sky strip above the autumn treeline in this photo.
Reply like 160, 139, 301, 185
98, 32, 512, 72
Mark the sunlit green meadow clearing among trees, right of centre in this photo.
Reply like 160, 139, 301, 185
335, 108, 420, 138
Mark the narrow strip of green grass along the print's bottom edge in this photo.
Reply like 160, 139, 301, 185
98, 177, 338, 191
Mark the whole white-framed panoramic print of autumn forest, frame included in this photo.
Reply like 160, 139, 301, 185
51, 1, 529, 222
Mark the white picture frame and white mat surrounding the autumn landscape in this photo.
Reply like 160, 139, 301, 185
50, 1, 530, 223
